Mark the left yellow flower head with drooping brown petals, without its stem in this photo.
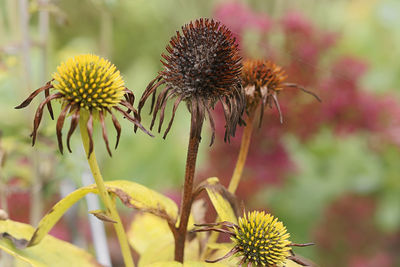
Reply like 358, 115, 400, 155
16, 54, 151, 156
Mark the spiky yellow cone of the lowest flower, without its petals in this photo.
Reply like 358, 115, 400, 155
232, 211, 291, 266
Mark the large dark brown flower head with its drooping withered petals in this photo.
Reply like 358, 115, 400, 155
139, 19, 245, 146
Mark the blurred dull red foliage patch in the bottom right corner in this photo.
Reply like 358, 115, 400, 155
315, 194, 400, 267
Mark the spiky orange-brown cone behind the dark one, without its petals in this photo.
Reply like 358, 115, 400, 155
242, 59, 287, 110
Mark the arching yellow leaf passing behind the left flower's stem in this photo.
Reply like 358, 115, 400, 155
28, 180, 178, 246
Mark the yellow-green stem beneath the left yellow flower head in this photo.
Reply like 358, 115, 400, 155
79, 111, 135, 267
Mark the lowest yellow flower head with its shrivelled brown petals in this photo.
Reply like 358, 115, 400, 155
195, 211, 312, 267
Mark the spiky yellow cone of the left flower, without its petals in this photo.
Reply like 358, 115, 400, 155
53, 54, 125, 110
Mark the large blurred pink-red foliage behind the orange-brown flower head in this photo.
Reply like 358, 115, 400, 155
210, 2, 400, 199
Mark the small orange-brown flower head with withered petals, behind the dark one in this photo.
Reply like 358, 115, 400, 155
242, 59, 320, 125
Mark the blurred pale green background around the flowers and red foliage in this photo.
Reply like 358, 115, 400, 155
0, 0, 400, 266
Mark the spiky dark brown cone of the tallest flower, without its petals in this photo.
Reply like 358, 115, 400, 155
161, 19, 242, 99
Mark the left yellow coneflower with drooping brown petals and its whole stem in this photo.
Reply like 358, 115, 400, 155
16, 55, 151, 266
